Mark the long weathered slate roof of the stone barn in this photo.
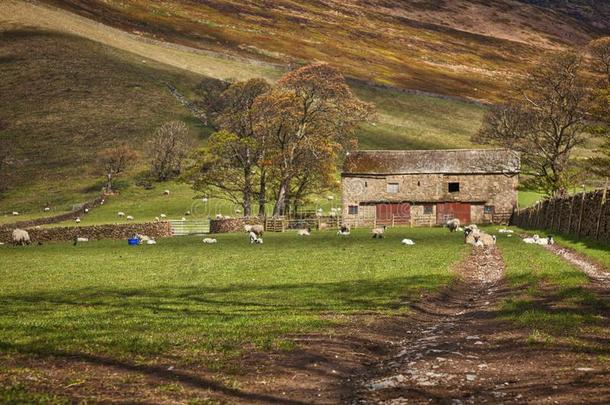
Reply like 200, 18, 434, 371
343, 149, 521, 175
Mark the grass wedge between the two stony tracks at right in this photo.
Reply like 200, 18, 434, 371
498, 227, 610, 351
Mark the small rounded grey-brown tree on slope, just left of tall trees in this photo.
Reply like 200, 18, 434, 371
147, 121, 192, 181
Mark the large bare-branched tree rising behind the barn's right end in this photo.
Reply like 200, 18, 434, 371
473, 52, 591, 195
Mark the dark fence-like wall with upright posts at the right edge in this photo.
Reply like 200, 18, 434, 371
511, 188, 610, 242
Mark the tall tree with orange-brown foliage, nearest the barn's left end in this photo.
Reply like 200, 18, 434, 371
255, 64, 372, 216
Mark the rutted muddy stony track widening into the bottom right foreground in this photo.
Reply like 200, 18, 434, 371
351, 247, 610, 404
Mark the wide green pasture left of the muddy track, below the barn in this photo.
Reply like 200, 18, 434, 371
0, 228, 467, 363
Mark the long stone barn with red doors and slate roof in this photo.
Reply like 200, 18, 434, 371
341, 149, 521, 226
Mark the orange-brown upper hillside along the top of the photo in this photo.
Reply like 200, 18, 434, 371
39, 0, 610, 100
